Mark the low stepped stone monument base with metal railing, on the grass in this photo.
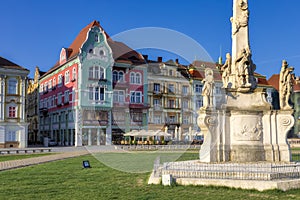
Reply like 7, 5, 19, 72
148, 160, 300, 191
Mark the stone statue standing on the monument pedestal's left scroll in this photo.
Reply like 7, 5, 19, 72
200, 68, 214, 110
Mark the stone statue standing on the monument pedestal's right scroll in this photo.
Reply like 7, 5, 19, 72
279, 60, 294, 110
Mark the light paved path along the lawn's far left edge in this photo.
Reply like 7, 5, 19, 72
0, 148, 89, 171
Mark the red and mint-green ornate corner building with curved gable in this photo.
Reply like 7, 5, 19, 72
39, 21, 148, 146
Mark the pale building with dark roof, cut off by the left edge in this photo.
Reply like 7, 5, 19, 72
0, 57, 29, 148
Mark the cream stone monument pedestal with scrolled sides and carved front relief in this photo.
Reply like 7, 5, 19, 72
197, 91, 294, 162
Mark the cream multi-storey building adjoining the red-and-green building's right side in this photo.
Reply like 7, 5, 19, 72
145, 56, 194, 141
